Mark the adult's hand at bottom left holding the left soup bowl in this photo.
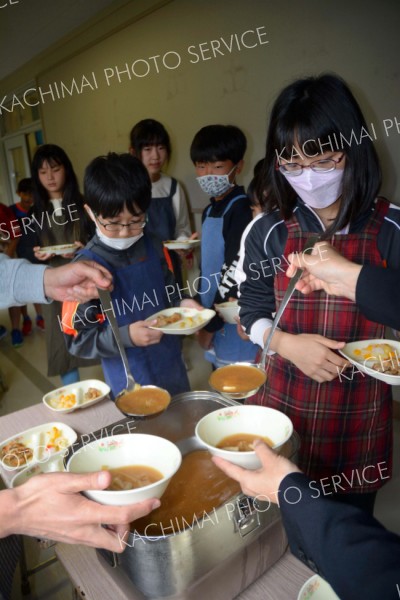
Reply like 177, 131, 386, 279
0, 471, 160, 552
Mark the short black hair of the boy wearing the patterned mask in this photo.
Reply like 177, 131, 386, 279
190, 125, 247, 164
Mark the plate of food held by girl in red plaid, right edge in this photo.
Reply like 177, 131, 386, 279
339, 339, 400, 385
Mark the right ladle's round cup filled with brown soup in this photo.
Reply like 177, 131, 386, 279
208, 362, 267, 400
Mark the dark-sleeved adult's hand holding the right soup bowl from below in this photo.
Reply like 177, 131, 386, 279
212, 440, 300, 504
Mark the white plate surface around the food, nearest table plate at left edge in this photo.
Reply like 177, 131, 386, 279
0, 422, 78, 471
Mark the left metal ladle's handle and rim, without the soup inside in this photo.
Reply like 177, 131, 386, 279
97, 288, 171, 418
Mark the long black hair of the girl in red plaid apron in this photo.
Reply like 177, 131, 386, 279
256, 74, 381, 237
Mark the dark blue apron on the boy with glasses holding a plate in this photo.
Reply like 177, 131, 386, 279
79, 236, 190, 397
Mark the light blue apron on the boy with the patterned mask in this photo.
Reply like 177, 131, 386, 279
200, 194, 258, 367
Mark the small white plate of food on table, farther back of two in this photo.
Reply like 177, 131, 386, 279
43, 379, 110, 413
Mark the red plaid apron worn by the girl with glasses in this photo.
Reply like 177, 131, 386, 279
248, 199, 392, 493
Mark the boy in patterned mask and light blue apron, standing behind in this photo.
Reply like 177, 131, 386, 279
190, 125, 258, 368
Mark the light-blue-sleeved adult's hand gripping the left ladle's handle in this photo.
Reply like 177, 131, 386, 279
44, 260, 112, 302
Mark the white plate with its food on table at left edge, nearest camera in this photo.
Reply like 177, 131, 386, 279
0, 422, 78, 471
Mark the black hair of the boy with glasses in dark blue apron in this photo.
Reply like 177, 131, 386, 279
83, 152, 151, 218
